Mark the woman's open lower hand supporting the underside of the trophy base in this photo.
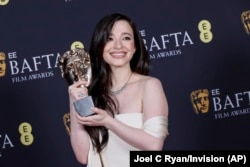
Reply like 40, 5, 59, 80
76, 107, 112, 126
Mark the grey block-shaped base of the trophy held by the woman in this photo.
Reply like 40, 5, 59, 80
74, 96, 94, 117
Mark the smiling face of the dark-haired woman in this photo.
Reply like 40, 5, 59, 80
103, 20, 136, 67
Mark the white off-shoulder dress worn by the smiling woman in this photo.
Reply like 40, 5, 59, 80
88, 113, 168, 167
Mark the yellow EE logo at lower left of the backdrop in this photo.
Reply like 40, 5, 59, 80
18, 122, 34, 146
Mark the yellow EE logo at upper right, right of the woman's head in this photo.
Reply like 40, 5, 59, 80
198, 20, 213, 43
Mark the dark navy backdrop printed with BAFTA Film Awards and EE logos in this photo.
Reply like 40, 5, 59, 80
0, 0, 250, 167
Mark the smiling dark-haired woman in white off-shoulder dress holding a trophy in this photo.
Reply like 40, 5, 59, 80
69, 13, 168, 167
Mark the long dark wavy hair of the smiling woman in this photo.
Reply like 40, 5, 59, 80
85, 13, 149, 152
